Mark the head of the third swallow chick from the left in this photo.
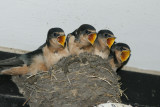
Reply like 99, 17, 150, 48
97, 30, 116, 49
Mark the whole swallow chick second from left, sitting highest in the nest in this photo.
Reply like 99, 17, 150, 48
67, 24, 97, 55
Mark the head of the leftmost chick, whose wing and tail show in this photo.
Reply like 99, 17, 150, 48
46, 28, 66, 48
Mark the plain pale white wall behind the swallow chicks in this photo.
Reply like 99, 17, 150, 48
0, 0, 160, 70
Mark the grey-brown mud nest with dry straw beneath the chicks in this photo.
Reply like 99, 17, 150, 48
12, 53, 122, 107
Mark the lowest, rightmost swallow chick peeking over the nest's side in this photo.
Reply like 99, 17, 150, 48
108, 43, 131, 71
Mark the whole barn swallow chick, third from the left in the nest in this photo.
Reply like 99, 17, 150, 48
93, 30, 116, 59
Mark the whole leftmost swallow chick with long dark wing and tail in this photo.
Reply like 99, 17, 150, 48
0, 28, 69, 75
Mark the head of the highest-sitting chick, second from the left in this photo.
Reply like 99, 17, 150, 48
76, 24, 97, 46
